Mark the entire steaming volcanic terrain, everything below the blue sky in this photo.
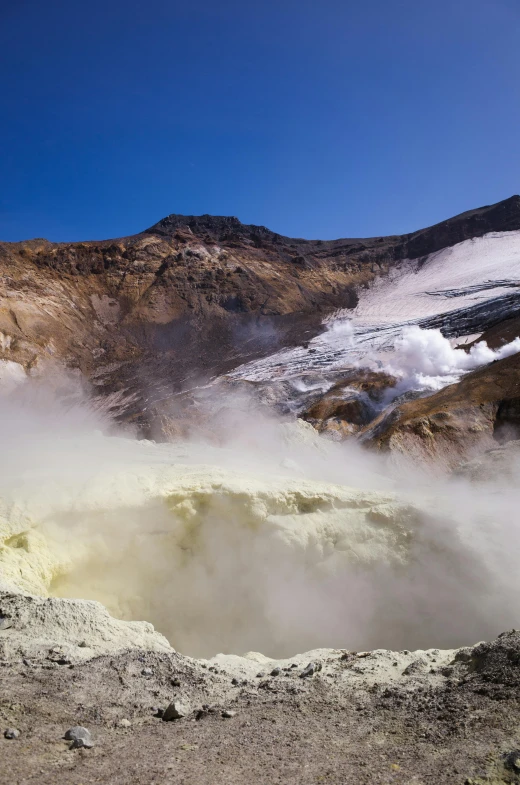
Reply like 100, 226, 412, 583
0, 196, 520, 785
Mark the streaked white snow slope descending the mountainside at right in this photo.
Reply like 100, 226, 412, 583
225, 231, 520, 382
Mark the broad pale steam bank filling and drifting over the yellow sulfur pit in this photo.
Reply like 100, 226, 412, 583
0, 376, 520, 656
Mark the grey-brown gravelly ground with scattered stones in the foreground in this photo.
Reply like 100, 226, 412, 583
0, 592, 520, 785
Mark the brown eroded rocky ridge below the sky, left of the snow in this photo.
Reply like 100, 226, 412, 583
0, 197, 520, 436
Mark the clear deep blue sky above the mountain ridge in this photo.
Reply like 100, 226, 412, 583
0, 0, 520, 240
